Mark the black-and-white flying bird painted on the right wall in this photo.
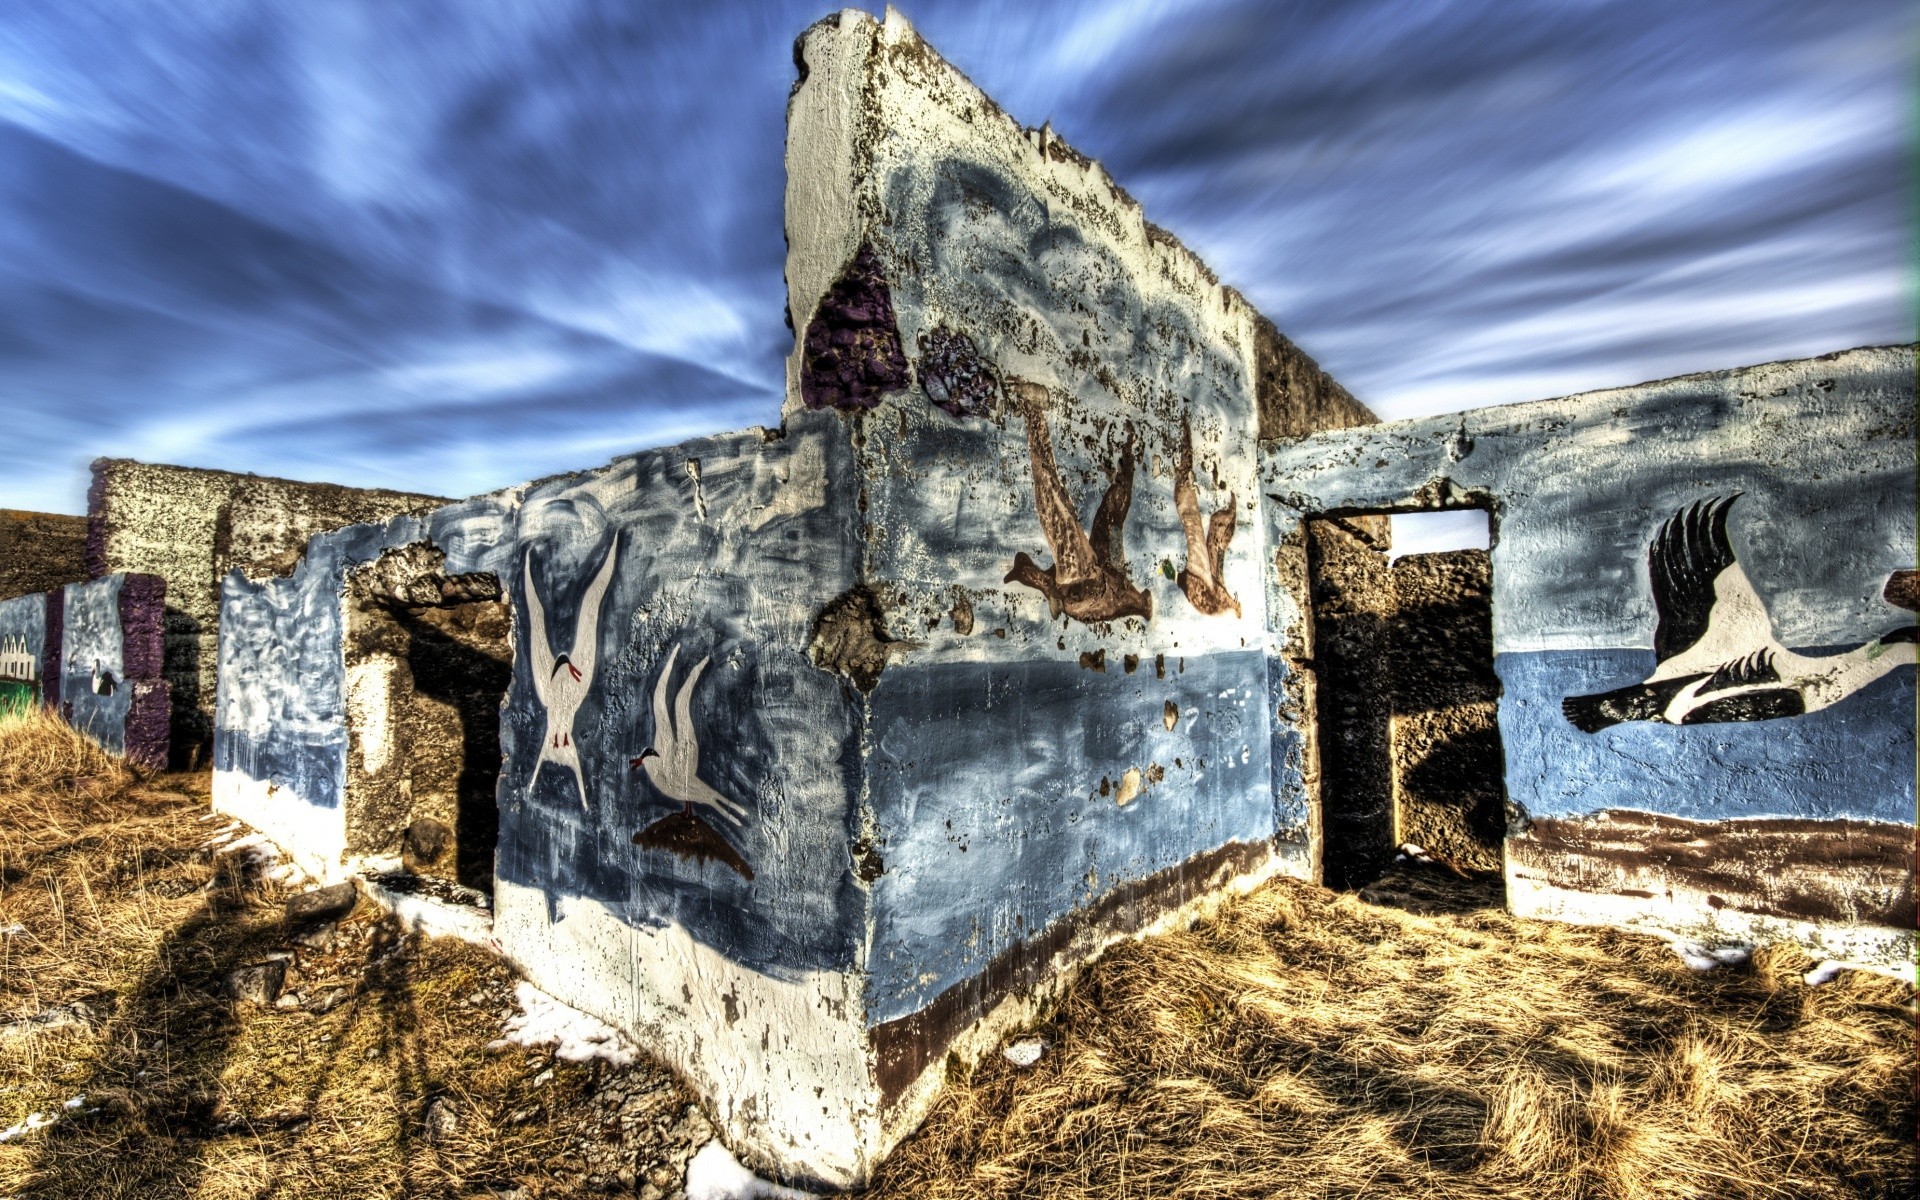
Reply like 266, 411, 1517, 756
1561, 492, 1920, 733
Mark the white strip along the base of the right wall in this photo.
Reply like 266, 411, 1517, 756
1507, 864, 1920, 983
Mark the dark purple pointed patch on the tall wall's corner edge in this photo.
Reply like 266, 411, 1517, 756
801, 246, 908, 413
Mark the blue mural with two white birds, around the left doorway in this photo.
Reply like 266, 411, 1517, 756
215, 413, 862, 975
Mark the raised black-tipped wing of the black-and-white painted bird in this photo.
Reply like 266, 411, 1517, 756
1647, 492, 1780, 682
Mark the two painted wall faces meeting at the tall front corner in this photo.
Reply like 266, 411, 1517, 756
215, 13, 1369, 1185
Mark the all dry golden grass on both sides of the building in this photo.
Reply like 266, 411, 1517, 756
0, 706, 1920, 1200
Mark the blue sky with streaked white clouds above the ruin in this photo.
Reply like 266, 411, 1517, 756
0, 0, 1916, 513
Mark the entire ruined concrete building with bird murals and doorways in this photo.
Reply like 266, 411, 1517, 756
3, 12, 1920, 1185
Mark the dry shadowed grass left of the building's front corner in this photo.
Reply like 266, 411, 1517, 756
0, 718, 707, 1200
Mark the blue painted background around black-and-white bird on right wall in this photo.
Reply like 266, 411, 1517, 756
1261, 348, 1916, 840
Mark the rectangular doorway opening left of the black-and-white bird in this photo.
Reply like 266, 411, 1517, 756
1308, 509, 1507, 889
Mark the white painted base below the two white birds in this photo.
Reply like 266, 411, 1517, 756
493, 881, 879, 1187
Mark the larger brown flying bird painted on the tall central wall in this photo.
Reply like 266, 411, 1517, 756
1002, 380, 1154, 624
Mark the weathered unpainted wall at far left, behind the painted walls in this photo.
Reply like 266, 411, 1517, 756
86, 459, 445, 766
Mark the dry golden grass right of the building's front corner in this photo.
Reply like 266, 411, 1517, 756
876, 868, 1920, 1200
